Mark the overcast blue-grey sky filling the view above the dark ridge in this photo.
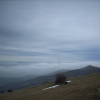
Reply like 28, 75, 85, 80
0, 0, 100, 76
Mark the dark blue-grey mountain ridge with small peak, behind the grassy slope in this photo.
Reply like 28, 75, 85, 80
0, 65, 100, 92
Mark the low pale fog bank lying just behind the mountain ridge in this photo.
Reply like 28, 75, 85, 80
0, 61, 100, 77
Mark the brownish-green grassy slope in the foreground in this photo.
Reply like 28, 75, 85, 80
0, 74, 100, 100
